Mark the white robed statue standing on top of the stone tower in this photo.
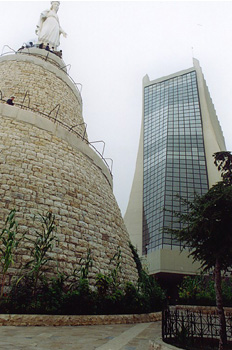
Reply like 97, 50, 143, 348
35, 1, 67, 51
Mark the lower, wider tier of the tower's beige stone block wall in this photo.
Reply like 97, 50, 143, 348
0, 113, 137, 281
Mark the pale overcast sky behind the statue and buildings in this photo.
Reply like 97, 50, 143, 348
0, 1, 232, 215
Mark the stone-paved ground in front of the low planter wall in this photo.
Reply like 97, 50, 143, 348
0, 322, 161, 350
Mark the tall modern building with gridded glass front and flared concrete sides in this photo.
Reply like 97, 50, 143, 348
124, 59, 226, 280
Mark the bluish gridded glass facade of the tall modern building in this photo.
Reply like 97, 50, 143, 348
143, 71, 208, 254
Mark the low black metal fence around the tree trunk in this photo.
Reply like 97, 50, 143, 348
162, 307, 232, 344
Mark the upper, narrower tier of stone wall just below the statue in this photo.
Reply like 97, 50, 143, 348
0, 50, 87, 138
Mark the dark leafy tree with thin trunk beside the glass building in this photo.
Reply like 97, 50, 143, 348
169, 152, 232, 350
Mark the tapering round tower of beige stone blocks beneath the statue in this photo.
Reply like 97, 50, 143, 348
0, 18, 137, 282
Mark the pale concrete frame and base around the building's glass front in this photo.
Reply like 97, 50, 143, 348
124, 59, 226, 274
